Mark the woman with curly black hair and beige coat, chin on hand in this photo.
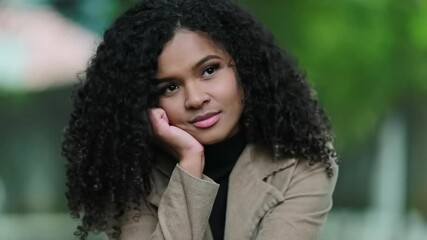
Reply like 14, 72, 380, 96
63, 0, 337, 240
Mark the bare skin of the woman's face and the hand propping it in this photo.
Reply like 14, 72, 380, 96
149, 30, 244, 178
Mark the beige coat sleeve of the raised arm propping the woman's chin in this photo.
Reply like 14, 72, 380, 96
107, 165, 219, 240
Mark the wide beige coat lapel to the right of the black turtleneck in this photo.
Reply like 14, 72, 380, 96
225, 145, 295, 239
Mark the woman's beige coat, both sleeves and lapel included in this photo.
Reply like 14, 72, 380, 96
107, 145, 338, 240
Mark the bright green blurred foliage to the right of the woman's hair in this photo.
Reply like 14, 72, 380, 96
241, 0, 427, 151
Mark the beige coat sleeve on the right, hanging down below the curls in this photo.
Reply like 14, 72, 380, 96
256, 161, 338, 240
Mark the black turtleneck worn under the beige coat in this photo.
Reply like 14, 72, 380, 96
204, 131, 246, 240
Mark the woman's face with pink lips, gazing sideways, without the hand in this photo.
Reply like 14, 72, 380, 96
157, 30, 244, 145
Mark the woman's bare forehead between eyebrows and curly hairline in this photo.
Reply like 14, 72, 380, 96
157, 30, 227, 75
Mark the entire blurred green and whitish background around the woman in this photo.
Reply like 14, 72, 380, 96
0, 0, 427, 240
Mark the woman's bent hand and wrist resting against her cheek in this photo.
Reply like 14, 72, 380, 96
148, 108, 205, 178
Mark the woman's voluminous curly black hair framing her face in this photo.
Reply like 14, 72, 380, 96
62, 0, 337, 239
